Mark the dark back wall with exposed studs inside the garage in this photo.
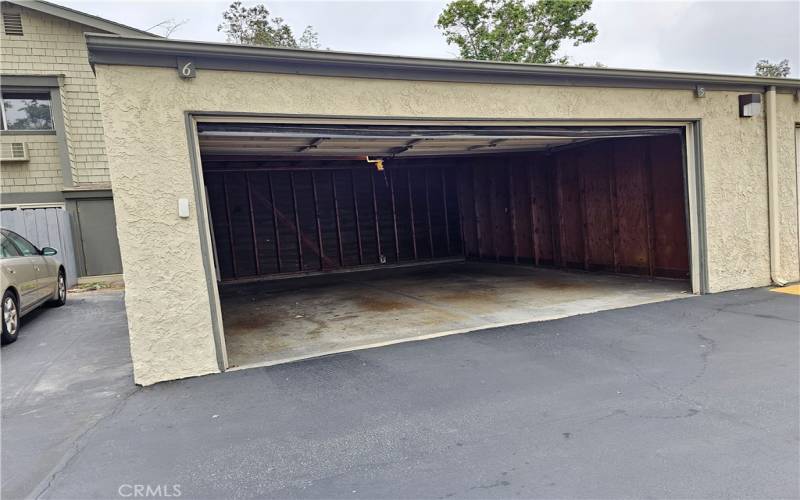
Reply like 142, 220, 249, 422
204, 162, 463, 280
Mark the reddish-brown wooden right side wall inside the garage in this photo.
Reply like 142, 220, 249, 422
458, 136, 689, 278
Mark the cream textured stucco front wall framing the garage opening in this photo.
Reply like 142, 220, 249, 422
92, 65, 800, 384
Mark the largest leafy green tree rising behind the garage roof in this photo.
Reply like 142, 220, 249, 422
436, 0, 597, 64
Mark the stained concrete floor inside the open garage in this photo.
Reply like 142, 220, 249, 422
220, 263, 691, 368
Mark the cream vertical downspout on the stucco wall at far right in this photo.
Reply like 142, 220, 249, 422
766, 85, 786, 286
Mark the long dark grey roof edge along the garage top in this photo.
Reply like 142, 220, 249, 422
86, 33, 800, 92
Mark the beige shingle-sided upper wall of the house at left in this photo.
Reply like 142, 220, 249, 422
0, 7, 110, 193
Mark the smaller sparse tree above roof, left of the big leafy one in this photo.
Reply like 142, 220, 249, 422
217, 0, 319, 49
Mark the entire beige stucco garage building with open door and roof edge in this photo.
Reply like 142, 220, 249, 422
87, 34, 800, 385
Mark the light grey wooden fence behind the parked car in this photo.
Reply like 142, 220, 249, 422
0, 208, 78, 286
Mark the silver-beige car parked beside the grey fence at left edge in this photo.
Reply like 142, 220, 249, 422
0, 229, 67, 344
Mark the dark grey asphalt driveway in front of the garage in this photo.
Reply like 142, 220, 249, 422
2, 289, 800, 498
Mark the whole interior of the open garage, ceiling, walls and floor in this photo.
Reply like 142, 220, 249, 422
198, 121, 691, 368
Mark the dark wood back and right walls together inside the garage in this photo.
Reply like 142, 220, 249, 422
205, 136, 689, 279
